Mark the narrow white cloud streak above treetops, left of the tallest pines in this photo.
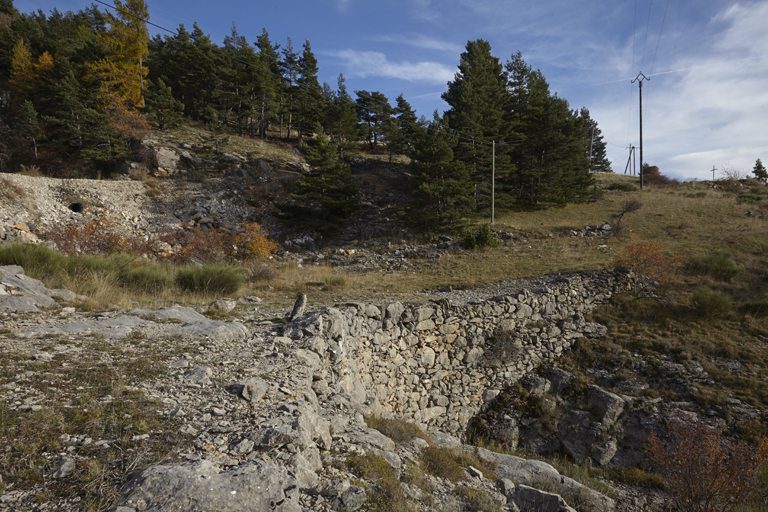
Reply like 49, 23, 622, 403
329, 50, 453, 83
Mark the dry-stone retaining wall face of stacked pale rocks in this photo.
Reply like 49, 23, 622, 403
283, 270, 635, 433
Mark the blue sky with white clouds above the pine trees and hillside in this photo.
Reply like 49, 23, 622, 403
15, 0, 768, 179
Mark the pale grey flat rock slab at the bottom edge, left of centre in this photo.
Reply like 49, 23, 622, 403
111, 460, 302, 512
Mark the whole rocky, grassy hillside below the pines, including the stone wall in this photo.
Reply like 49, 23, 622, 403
0, 127, 768, 512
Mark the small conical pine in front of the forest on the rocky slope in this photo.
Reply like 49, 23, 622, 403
280, 125, 359, 235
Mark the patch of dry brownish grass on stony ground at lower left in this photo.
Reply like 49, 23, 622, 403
0, 344, 189, 511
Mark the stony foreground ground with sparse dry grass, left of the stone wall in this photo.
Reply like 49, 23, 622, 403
0, 267, 676, 512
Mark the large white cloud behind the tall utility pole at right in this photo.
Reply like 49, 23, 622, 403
593, 3, 768, 179
